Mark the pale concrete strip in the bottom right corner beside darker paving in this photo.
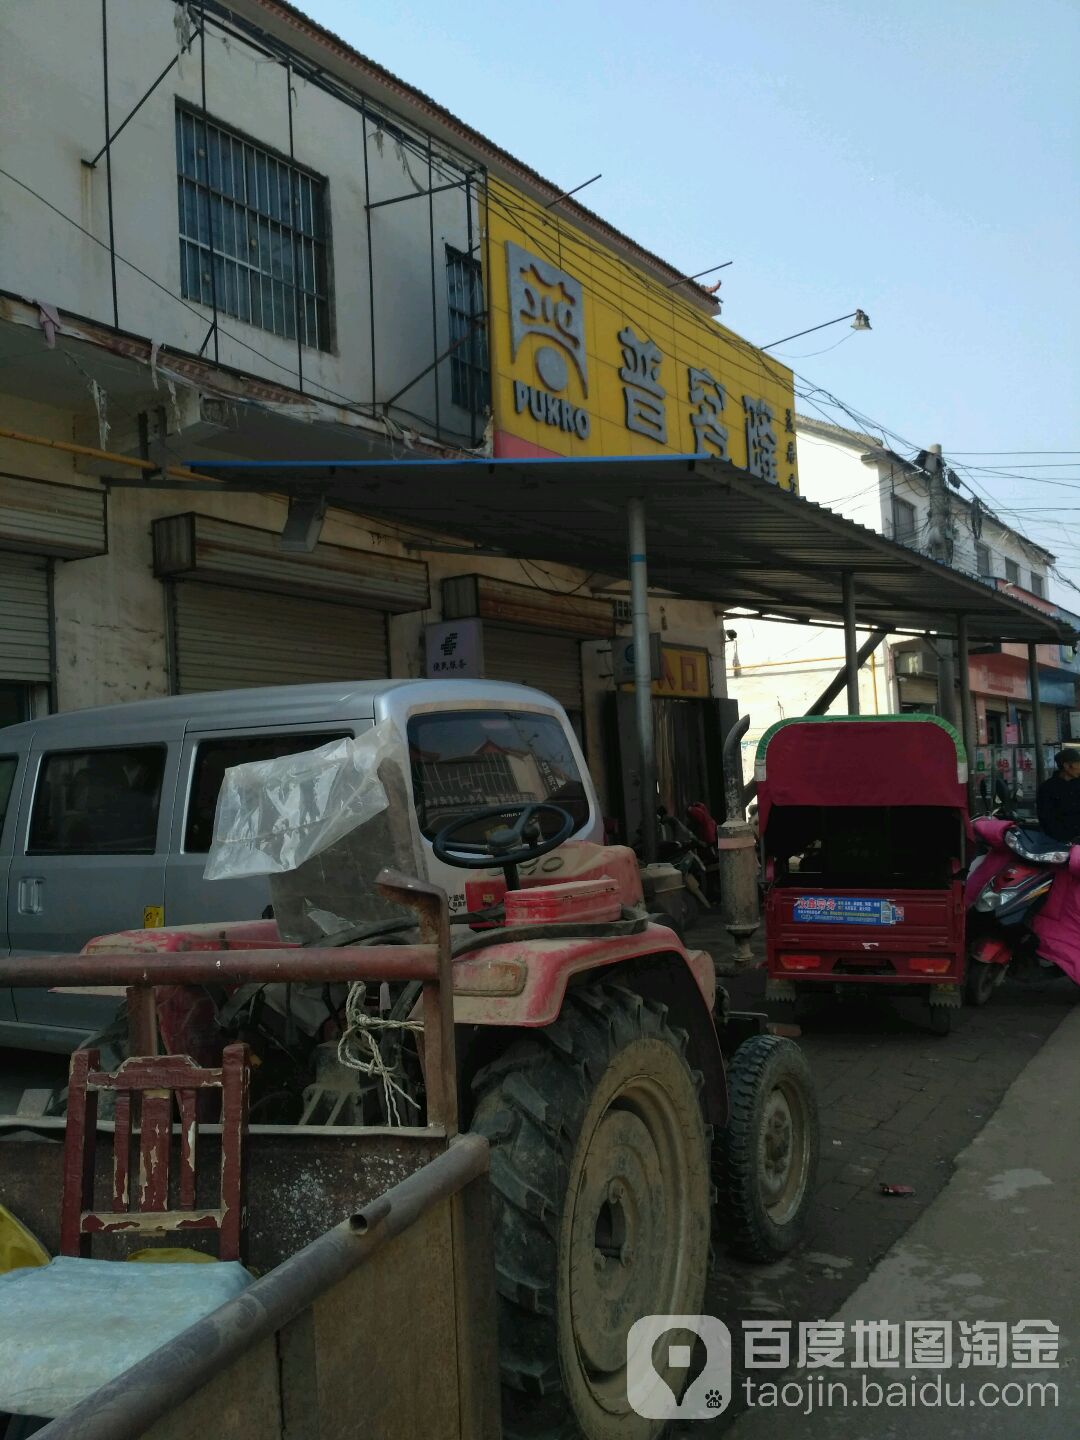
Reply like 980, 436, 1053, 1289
727, 1008, 1080, 1440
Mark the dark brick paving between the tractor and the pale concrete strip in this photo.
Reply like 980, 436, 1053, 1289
685, 927, 1080, 1440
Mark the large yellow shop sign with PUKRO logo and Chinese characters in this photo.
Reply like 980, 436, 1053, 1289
487, 177, 799, 490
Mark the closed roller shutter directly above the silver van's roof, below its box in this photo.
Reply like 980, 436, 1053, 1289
173, 583, 390, 694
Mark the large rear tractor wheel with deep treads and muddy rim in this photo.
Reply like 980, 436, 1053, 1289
472, 985, 711, 1440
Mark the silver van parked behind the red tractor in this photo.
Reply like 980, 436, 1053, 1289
0, 680, 603, 1050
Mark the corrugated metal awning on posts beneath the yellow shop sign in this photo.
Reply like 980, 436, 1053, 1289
192, 455, 1073, 644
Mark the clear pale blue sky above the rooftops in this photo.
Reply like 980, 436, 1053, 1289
301, 0, 1080, 593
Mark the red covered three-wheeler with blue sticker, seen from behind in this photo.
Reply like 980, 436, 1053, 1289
756, 714, 971, 1034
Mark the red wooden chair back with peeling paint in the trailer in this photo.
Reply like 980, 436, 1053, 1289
60, 1045, 251, 1260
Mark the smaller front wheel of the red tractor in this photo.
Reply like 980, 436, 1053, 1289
716, 1035, 818, 1260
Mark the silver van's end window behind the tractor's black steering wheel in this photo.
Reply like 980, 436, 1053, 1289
409, 710, 589, 841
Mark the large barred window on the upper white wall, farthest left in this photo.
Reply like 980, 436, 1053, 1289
176, 109, 330, 350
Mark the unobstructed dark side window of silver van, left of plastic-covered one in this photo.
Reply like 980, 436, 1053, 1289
29, 744, 166, 855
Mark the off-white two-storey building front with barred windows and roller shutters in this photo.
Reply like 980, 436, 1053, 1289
0, 0, 743, 835
